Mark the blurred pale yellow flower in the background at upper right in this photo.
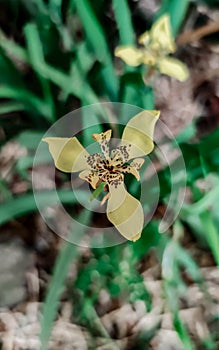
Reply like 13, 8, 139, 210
115, 15, 189, 81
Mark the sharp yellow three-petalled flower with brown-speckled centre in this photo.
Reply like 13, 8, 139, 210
43, 111, 160, 241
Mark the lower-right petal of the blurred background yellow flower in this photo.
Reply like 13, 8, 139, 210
158, 57, 189, 81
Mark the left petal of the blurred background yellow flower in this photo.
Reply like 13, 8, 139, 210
115, 46, 143, 67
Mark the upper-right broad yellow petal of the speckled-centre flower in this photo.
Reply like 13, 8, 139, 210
122, 111, 160, 159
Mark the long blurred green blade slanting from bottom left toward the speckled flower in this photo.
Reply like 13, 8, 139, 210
40, 211, 91, 350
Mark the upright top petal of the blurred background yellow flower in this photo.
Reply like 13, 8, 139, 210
150, 14, 176, 53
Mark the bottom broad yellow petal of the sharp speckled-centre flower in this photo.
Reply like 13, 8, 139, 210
107, 182, 144, 242
